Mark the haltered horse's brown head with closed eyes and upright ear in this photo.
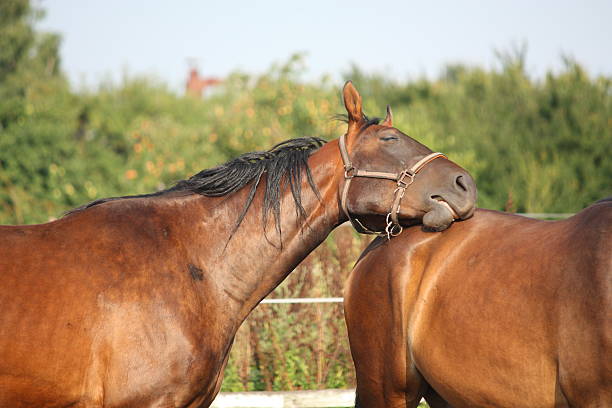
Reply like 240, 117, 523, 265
339, 81, 476, 236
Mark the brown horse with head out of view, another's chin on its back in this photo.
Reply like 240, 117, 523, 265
345, 200, 612, 408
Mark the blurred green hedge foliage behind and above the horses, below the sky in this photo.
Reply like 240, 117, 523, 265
0, 44, 612, 223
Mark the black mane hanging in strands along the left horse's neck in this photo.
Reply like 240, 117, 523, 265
65, 137, 326, 239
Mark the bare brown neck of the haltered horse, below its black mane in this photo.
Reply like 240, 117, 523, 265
188, 142, 344, 322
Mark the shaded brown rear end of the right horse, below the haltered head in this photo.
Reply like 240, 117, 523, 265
345, 236, 436, 406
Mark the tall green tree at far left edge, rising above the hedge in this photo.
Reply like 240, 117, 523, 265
0, 0, 74, 222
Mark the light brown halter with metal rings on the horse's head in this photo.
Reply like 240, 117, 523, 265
338, 134, 446, 239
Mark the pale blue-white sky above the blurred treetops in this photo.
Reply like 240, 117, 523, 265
38, 0, 612, 90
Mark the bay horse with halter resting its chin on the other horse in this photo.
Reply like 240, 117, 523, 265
0, 82, 476, 408
